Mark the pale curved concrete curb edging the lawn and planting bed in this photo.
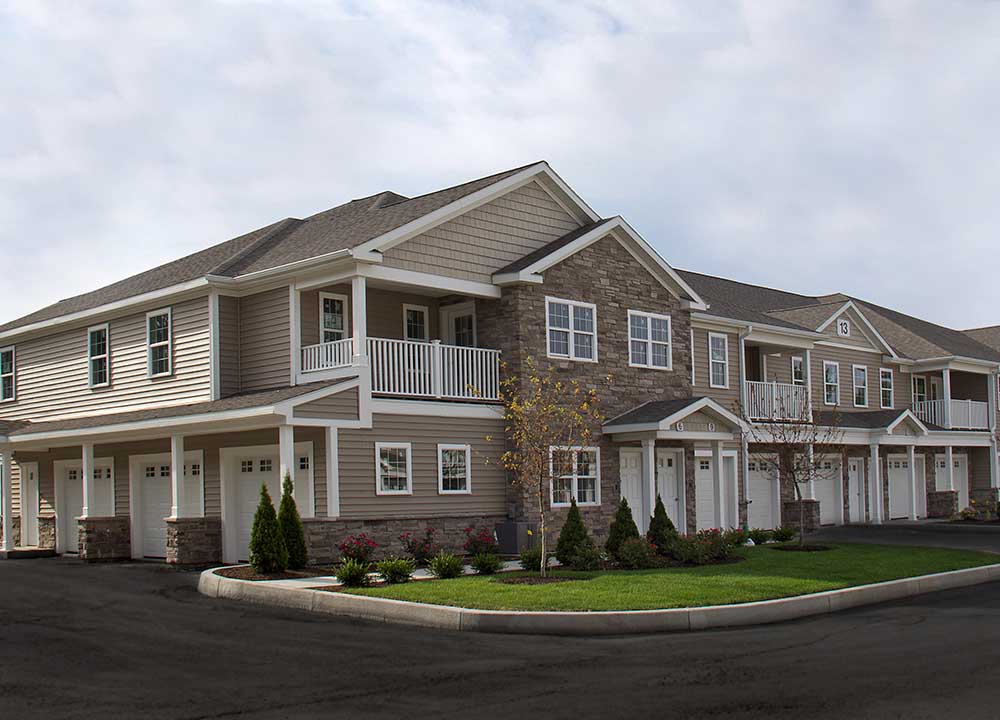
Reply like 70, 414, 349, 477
198, 564, 1000, 635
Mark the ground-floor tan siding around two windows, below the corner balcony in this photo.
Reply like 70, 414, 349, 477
339, 415, 507, 518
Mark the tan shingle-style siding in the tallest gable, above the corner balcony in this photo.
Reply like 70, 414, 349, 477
385, 182, 579, 282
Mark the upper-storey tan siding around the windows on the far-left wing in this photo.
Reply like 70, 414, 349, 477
2, 297, 211, 421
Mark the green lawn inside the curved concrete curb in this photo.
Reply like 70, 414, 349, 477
349, 544, 1000, 610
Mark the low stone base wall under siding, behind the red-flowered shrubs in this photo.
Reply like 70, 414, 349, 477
302, 515, 507, 564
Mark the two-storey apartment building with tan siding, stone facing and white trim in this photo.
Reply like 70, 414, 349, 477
0, 162, 1000, 564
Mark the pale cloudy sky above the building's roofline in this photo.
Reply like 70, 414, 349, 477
0, 0, 1000, 328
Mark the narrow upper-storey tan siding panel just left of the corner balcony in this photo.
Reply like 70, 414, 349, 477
240, 287, 291, 392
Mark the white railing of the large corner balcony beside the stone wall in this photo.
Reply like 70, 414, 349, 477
301, 338, 500, 402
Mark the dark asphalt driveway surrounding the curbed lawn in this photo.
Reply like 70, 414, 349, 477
0, 528, 1000, 720
